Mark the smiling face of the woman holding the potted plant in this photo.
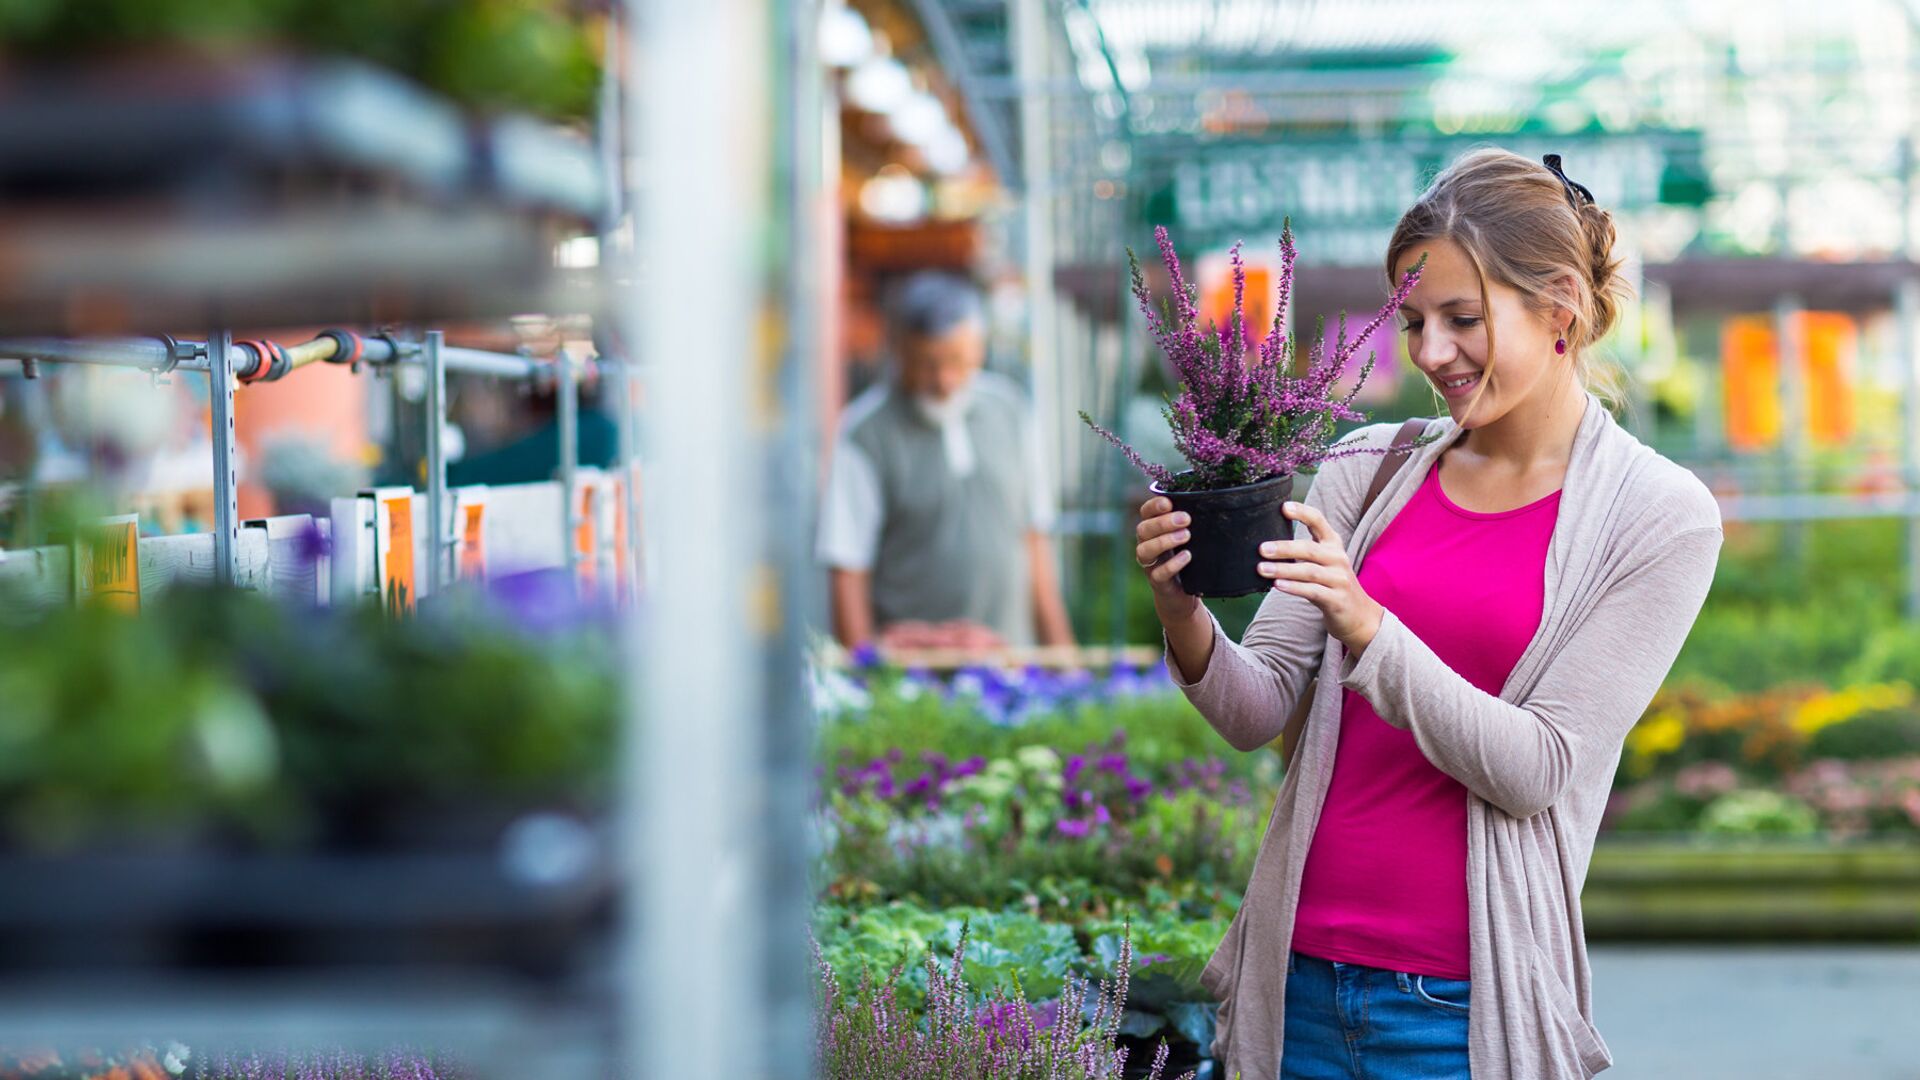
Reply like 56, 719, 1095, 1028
1394, 238, 1574, 429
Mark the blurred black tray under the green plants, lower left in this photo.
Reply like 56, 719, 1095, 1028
0, 851, 616, 982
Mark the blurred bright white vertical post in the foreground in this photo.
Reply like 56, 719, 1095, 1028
629, 0, 779, 1078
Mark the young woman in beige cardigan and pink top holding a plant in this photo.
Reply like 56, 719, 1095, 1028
1137, 150, 1720, 1080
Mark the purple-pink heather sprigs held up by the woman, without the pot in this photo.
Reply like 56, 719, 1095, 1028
1081, 219, 1432, 492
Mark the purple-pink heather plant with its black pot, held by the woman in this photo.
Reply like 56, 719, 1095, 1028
1081, 219, 1434, 596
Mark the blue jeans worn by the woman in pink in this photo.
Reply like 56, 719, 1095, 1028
1281, 953, 1471, 1080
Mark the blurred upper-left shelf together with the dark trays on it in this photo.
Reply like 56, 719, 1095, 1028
0, 56, 605, 334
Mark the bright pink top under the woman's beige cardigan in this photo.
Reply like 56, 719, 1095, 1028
1292, 453, 1559, 978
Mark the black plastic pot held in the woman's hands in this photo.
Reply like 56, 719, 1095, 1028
1150, 473, 1294, 596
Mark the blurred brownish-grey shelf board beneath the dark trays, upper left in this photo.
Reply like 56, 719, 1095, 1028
0, 206, 593, 336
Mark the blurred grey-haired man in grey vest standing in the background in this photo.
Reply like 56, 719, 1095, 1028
818, 271, 1073, 648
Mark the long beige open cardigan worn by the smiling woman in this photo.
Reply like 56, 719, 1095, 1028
1167, 394, 1722, 1080
